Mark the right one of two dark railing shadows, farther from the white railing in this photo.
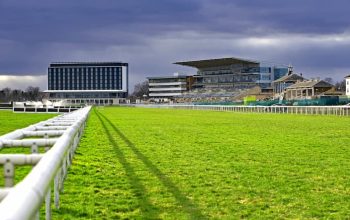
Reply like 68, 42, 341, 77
95, 110, 207, 219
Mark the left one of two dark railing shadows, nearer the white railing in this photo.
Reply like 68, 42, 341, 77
94, 109, 159, 219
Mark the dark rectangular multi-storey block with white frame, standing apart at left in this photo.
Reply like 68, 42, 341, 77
45, 62, 128, 105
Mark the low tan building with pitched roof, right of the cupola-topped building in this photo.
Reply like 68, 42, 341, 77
285, 80, 334, 100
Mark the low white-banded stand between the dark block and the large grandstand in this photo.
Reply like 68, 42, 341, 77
147, 73, 193, 102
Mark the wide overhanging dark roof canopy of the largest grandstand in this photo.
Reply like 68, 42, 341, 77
174, 57, 260, 69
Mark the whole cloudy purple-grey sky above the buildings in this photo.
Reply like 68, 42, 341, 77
0, 0, 350, 89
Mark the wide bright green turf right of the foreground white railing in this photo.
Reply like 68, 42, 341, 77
53, 108, 350, 219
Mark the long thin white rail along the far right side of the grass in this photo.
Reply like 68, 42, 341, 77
135, 105, 350, 116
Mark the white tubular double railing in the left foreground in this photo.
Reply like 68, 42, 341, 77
0, 107, 91, 220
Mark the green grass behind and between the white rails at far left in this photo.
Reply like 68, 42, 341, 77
0, 110, 55, 187
